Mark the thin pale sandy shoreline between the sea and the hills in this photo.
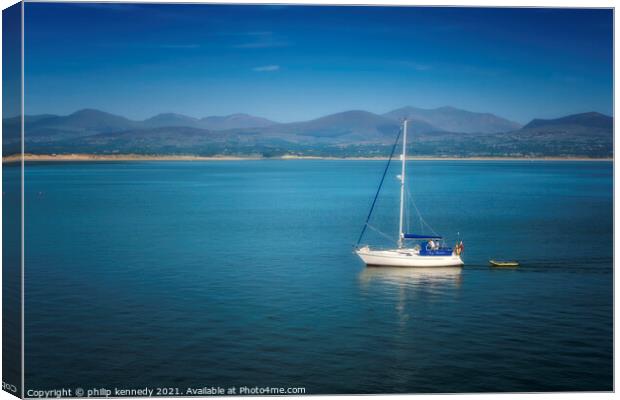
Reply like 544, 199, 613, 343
2, 154, 613, 164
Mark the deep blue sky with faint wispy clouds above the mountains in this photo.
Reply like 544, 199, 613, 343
25, 3, 613, 122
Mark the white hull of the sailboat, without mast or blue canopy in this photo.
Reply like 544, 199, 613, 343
355, 247, 463, 268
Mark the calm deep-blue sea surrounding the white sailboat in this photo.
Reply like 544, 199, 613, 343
17, 160, 613, 394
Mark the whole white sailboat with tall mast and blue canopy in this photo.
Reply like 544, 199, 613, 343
355, 119, 463, 267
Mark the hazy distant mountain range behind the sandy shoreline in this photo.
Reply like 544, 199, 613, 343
3, 107, 613, 158
